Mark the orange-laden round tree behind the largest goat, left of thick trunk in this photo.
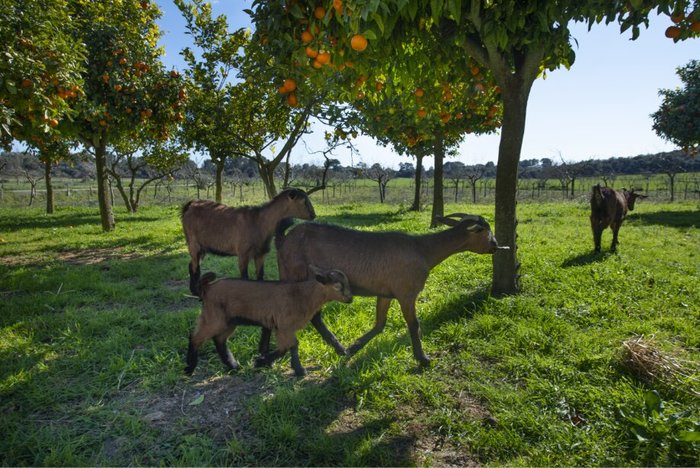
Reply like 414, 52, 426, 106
327, 30, 501, 225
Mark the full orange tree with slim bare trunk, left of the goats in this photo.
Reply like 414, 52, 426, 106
57, 0, 186, 231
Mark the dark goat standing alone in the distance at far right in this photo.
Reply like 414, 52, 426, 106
591, 184, 647, 252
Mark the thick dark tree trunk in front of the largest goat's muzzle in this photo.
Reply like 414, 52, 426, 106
491, 77, 532, 296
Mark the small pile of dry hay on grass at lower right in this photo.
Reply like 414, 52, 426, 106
622, 336, 700, 397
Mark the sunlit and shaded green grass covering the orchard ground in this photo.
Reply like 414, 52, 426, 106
0, 200, 700, 466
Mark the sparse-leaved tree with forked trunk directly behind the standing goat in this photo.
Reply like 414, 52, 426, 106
175, 0, 322, 202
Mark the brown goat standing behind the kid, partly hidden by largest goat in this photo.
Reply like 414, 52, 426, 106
182, 189, 316, 296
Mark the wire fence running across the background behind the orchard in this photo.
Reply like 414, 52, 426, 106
0, 173, 700, 208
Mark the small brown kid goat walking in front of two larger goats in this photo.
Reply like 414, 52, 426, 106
185, 265, 352, 376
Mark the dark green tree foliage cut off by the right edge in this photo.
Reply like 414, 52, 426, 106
651, 60, 700, 156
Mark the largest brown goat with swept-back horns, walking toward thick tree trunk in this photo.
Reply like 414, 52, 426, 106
270, 213, 508, 365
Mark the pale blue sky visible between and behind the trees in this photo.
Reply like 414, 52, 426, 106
157, 0, 700, 168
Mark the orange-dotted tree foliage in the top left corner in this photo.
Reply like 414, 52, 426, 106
0, 0, 84, 147
